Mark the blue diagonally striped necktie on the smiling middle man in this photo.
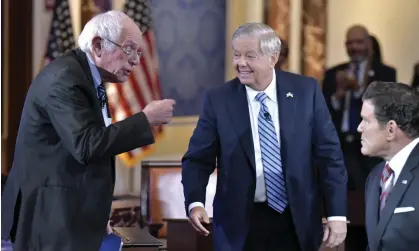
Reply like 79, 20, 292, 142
256, 92, 288, 213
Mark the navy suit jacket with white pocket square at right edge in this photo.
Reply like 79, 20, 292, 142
365, 145, 419, 251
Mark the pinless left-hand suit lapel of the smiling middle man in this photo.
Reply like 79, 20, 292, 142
227, 78, 256, 171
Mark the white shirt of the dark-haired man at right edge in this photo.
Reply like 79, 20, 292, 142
382, 138, 419, 190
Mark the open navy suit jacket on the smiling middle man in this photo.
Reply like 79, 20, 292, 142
182, 71, 347, 251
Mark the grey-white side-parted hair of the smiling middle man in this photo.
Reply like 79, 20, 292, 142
232, 23, 281, 56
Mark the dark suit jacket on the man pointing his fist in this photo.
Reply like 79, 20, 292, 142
1, 50, 154, 251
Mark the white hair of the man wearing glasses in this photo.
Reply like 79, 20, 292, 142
78, 10, 128, 53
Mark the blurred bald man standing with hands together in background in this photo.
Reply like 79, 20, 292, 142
323, 25, 396, 190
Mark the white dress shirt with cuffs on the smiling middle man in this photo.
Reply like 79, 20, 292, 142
188, 70, 346, 221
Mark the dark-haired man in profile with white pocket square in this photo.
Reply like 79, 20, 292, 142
358, 82, 419, 251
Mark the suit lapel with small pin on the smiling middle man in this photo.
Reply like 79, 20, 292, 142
276, 71, 298, 164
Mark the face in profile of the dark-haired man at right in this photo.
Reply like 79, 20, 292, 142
358, 100, 389, 157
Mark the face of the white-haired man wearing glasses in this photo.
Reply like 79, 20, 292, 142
94, 19, 142, 83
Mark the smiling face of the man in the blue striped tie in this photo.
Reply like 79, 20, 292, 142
233, 37, 277, 87
